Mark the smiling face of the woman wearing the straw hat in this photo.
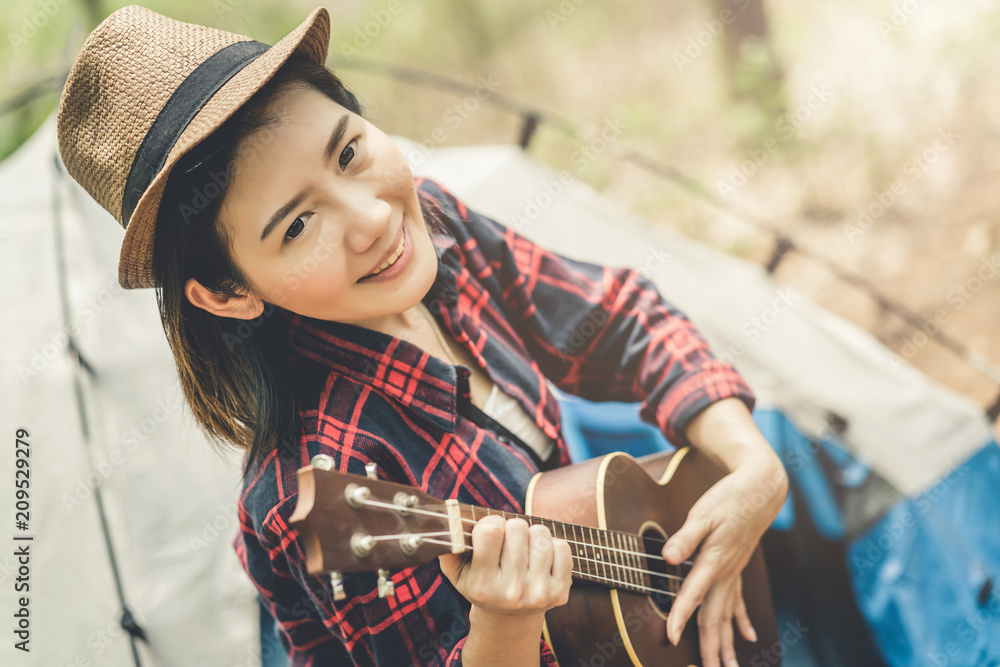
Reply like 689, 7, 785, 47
219, 86, 437, 329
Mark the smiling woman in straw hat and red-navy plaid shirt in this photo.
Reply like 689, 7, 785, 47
58, 7, 787, 666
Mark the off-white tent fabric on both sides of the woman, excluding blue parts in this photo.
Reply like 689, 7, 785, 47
0, 118, 991, 667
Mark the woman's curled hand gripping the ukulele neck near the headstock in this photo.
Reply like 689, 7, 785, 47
439, 515, 573, 624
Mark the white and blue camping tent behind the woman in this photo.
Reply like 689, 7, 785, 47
0, 118, 1000, 666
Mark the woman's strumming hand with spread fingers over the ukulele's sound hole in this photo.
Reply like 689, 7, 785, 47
663, 454, 788, 667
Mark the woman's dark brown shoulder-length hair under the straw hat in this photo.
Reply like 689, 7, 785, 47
153, 56, 450, 479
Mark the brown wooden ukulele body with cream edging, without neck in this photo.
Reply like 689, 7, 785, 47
525, 448, 781, 667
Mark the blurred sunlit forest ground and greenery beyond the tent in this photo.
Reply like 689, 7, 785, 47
0, 0, 1000, 426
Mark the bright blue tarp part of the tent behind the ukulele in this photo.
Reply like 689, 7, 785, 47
560, 395, 1000, 667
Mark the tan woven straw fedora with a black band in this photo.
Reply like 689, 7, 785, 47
56, 6, 330, 289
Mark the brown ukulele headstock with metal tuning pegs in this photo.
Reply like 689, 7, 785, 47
289, 455, 467, 595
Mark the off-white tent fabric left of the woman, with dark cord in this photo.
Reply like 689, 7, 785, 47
0, 117, 260, 667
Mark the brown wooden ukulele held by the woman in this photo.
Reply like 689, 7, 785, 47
290, 447, 781, 667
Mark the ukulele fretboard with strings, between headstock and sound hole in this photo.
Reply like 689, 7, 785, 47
460, 504, 686, 595
